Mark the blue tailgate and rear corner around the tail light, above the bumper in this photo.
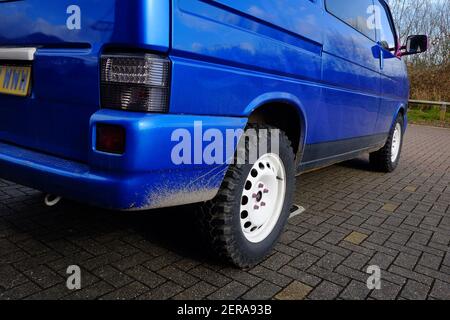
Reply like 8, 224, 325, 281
0, 0, 170, 162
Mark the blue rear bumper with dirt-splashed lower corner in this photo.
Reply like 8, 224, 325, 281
0, 110, 246, 210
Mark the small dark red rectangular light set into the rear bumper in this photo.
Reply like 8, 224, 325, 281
95, 124, 125, 154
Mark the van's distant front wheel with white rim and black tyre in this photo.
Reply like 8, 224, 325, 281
370, 114, 405, 172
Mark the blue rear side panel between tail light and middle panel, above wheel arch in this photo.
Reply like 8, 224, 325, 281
170, 0, 323, 126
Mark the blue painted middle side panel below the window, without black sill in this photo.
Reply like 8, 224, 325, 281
321, 9, 380, 140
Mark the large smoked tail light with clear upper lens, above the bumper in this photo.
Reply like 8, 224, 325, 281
101, 54, 170, 113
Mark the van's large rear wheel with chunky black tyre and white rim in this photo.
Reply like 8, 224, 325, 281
199, 125, 295, 268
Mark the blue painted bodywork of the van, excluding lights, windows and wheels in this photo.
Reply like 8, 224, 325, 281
0, 0, 409, 209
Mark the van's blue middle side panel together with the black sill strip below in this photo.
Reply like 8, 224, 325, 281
301, 1, 387, 170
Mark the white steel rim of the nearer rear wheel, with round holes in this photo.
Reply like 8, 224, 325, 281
240, 153, 286, 243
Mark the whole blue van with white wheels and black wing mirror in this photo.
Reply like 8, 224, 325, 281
0, 0, 427, 268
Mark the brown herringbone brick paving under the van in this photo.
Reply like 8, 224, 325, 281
0, 126, 450, 299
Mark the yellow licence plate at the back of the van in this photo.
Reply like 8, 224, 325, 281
0, 63, 31, 97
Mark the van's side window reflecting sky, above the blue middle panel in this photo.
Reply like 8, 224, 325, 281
325, 0, 378, 41
